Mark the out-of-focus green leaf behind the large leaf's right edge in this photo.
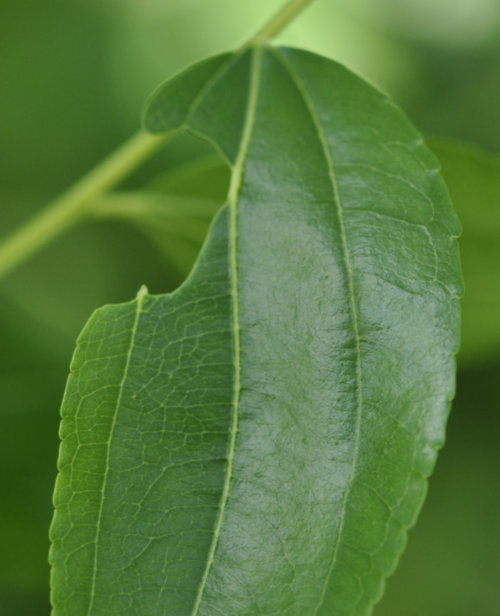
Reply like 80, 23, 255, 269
430, 139, 500, 365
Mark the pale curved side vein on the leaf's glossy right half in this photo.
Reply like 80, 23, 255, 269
271, 49, 363, 616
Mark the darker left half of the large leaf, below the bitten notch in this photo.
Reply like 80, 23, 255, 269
51, 213, 232, 615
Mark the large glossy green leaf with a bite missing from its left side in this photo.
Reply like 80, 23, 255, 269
51, 48, 460, 616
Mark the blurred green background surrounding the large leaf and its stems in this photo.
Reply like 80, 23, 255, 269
0, 0, 500, 616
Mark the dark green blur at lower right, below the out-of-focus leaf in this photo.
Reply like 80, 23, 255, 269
374, 360, 500, 616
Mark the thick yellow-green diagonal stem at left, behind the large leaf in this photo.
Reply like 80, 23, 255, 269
0, 132, 166, 278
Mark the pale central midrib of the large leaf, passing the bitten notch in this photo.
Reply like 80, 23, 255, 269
191, 47, 262, 616
